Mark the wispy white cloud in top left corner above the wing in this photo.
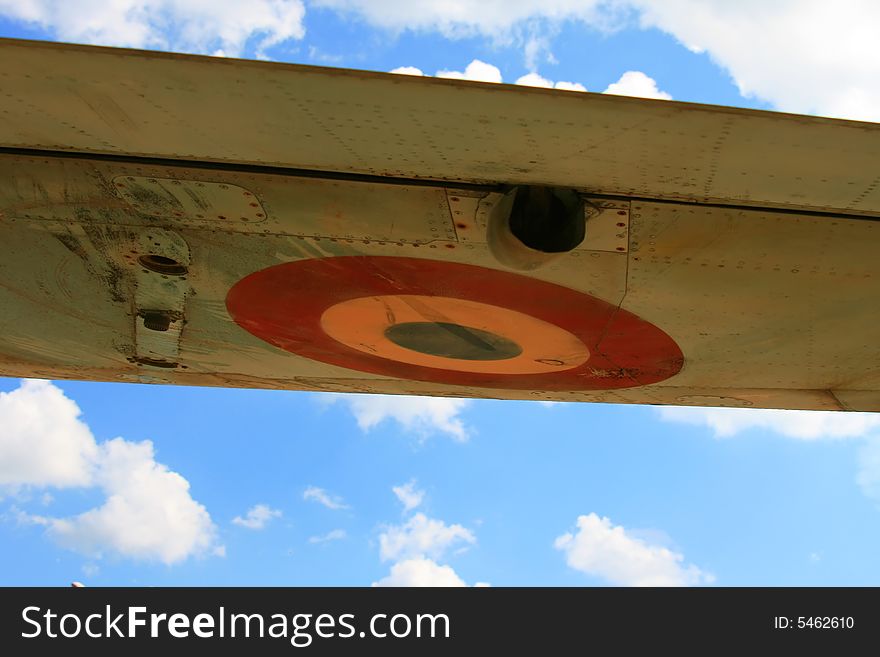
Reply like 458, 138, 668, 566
0, 0, 305, 57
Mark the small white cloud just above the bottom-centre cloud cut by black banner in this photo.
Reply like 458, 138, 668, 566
379, 513, 477, 561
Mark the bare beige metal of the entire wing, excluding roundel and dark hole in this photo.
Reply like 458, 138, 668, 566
0, 40, 880, 410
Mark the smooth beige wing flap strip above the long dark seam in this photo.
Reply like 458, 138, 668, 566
0, 39, 880, 214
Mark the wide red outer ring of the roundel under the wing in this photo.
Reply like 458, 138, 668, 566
226, 256, 683, 391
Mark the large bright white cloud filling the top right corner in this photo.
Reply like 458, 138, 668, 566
628, 0, 880, 121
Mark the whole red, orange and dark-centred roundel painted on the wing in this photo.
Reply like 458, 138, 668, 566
226, 256, 683, 391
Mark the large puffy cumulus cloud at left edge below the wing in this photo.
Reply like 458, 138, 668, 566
0, 381, 221, 564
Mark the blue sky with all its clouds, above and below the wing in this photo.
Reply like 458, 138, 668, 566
0, 0, 880, 586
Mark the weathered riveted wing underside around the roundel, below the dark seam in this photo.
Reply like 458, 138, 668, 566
0, 156, 880, 409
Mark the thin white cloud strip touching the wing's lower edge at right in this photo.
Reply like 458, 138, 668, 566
659, 406, 880, 440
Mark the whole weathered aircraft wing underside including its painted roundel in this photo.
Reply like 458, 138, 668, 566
0, 40, 880, 411
